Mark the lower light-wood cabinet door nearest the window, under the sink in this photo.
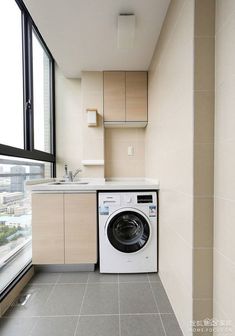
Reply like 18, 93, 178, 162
32, 194, 64, 264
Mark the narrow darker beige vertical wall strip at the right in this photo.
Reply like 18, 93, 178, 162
193, 0, 215, 335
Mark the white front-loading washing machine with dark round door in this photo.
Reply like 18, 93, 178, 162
98, 190, 158, 273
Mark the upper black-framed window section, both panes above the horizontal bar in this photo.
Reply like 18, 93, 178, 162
0, 0, 55, 162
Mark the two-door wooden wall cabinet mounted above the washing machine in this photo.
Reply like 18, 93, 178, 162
104, 71, 148, 127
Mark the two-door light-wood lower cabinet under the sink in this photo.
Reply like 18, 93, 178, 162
32, 193, 97, 264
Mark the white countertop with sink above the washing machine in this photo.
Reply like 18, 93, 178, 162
31, 179, 159, 193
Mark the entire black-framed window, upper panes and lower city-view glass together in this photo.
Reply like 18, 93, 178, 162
0, 0, 55, 296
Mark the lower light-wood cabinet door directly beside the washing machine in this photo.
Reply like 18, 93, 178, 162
64, 193, 97, 264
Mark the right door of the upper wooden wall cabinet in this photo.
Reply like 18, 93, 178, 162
126, 71, 148, 121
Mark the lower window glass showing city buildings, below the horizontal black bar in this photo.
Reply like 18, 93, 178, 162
0, 156, 51, 292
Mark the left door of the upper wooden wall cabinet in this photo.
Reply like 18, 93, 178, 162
104, 71, 125, 121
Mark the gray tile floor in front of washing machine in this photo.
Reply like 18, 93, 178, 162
0, 271, 182, 336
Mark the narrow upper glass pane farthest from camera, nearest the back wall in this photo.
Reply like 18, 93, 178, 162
33, 32, 51, 153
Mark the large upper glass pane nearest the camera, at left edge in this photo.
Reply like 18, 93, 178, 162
0, 0, 24, 148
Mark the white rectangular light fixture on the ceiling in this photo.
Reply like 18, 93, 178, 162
117, 14, 135, 49
